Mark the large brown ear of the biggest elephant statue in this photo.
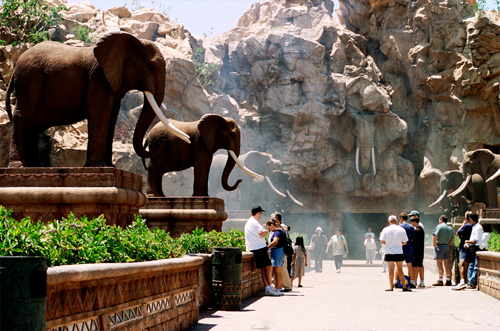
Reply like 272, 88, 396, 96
94, 32, 144, 93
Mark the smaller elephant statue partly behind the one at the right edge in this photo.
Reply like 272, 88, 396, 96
429, 170, 487, 216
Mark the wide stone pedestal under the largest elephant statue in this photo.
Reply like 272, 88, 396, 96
0, 167, 147, 227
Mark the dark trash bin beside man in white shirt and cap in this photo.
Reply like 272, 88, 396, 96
212, 247, 242, 310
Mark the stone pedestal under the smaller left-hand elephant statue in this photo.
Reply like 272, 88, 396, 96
139, 197, 227, 237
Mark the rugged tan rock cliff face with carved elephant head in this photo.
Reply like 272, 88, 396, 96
0, 0, 500, 217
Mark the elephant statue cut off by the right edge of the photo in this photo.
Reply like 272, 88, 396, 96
448, 149, 500, 208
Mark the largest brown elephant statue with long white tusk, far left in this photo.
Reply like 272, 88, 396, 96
6, 32, 189, 167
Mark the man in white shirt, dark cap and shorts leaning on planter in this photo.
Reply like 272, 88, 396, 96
245, 206, 281, 296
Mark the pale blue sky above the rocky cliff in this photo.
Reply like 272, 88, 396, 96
76, 0, 496, 36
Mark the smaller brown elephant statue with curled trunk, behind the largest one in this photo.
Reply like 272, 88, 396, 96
143, 114, 259, 196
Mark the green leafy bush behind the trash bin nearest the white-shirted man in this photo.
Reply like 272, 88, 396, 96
179, 228, 245, 254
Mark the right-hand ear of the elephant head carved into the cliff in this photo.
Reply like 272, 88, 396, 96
375, 112, 408, 152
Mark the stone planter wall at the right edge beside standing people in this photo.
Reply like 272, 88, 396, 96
477, 252, 500, 299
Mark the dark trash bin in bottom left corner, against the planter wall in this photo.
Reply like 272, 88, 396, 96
0, 256, 47, 331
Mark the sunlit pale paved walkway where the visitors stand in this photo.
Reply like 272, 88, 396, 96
190, 260, 500, 331
